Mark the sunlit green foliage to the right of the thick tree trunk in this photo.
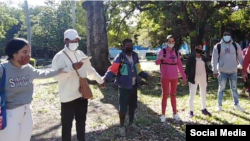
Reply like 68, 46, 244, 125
108, 0, 250, 47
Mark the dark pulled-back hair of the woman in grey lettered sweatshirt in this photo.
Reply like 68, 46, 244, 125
5, 38, 29, 60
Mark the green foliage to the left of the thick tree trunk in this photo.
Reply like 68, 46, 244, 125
0, 0, 86, 58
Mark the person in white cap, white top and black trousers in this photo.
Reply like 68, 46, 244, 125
52, 29, 104, 141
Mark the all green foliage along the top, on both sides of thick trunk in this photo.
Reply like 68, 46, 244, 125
0, 0, 250, 54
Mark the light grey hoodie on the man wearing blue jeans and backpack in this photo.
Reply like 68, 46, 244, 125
211, 40, 243, 74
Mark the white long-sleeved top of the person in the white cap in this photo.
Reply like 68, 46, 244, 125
52, 46, 104, 103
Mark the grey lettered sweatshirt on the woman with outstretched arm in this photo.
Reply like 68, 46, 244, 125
0, 61, 59, 109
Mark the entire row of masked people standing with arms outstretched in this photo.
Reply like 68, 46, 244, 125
0, 29, 250, 141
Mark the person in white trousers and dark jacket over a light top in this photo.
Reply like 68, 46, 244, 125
185, 43, 212, 117
